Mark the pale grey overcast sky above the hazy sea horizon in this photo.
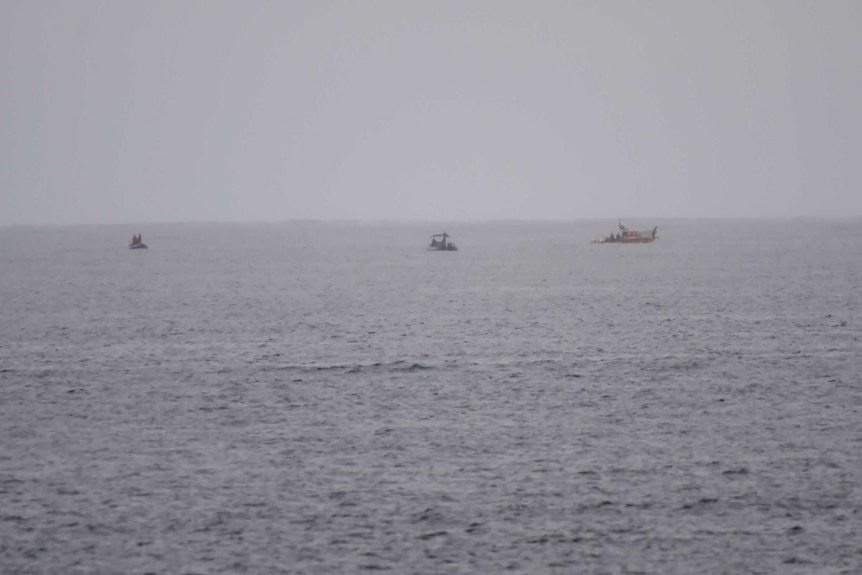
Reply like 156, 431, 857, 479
0, 0, 862, 225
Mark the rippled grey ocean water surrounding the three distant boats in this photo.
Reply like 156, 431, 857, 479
0, 220, 862, 575
